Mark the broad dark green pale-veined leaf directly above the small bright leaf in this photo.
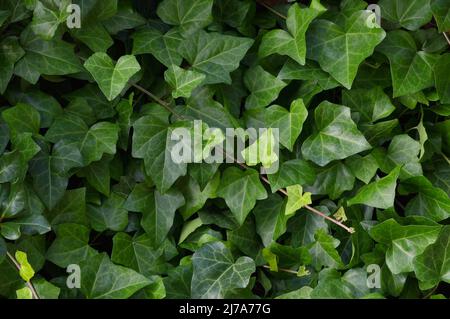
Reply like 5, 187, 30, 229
180, 31, 253, 84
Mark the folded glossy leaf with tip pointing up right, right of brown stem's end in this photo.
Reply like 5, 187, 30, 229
347, 166, 400, 209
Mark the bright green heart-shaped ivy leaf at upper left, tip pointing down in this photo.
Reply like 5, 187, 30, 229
84, 52, 141, 101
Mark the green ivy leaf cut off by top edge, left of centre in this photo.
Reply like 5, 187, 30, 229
157, 0, 214, 32
